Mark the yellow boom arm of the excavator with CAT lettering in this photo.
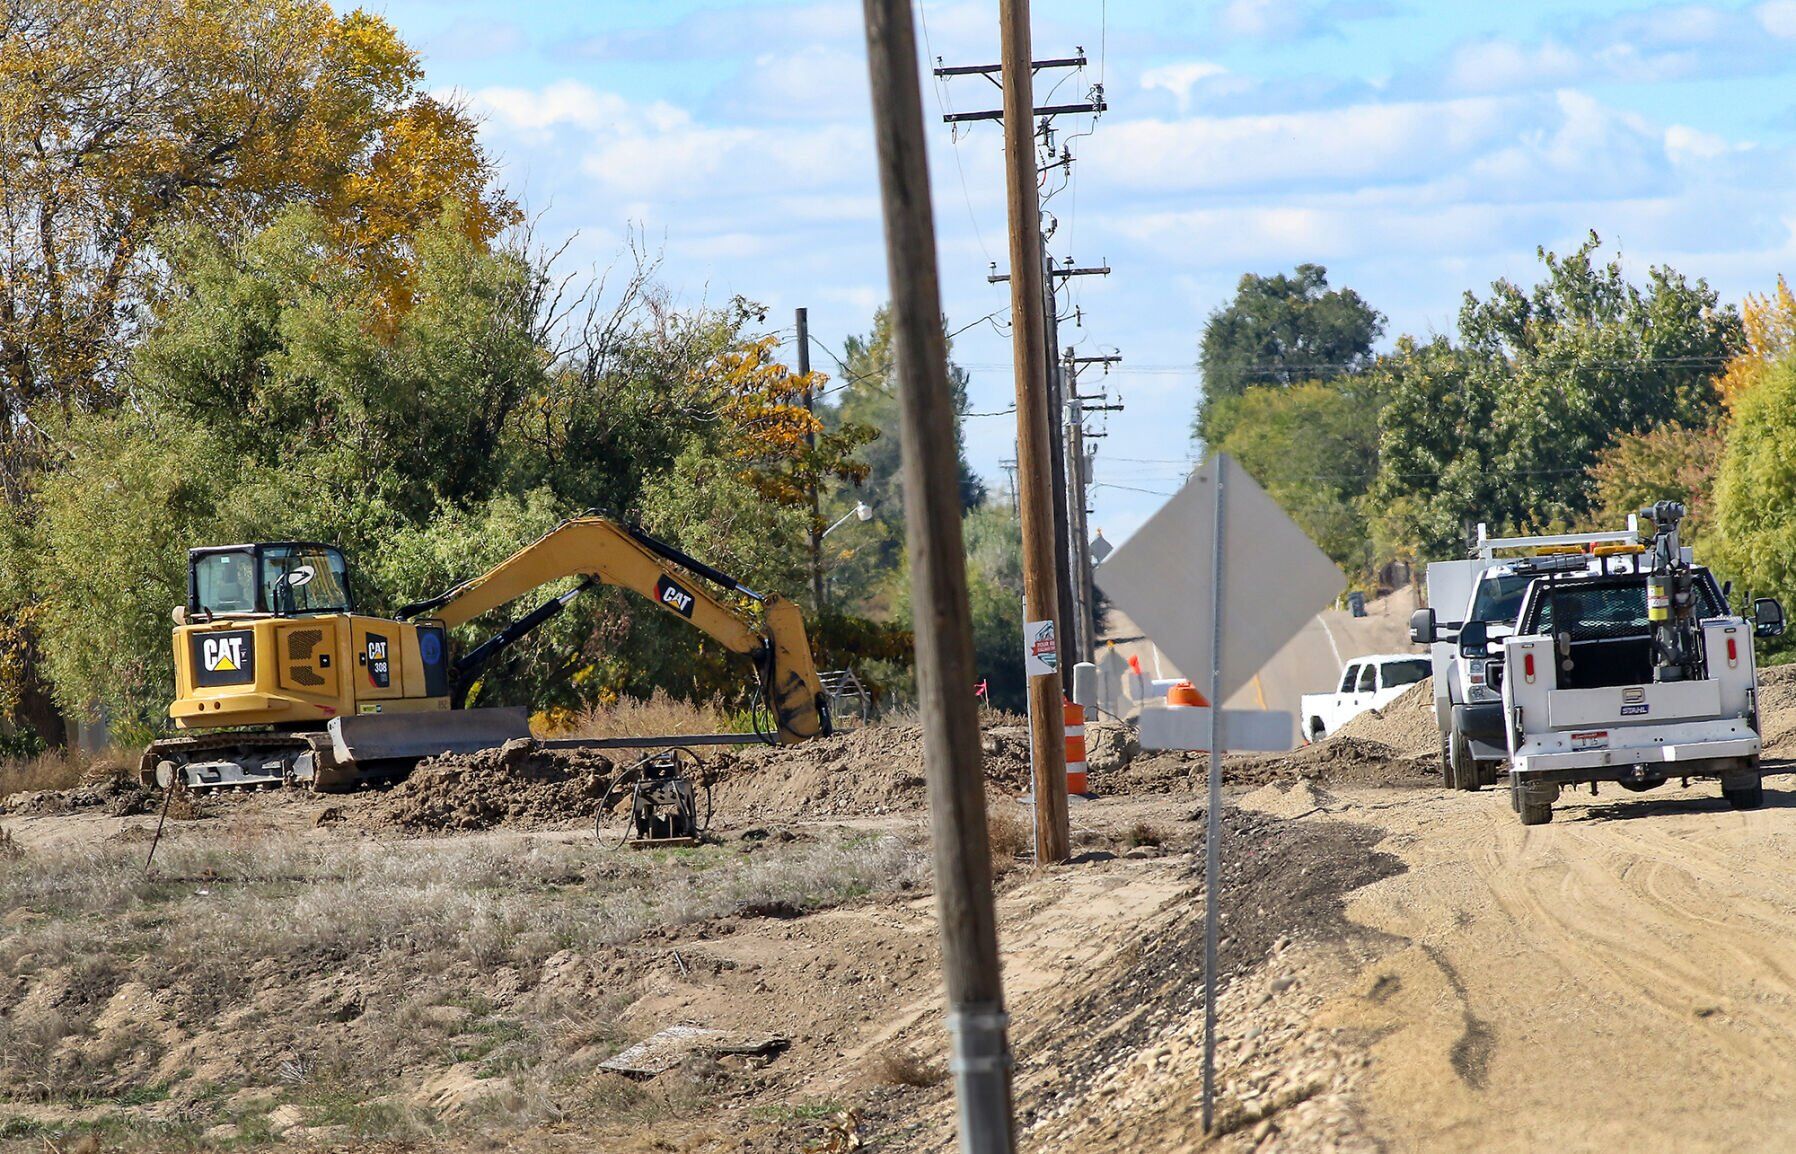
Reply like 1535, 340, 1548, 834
399, 513, 830, 743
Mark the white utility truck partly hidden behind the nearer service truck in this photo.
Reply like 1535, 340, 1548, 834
1410, 517, 1640, 790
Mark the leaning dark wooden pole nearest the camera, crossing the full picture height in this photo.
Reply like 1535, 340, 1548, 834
864, 0, 1020, 1154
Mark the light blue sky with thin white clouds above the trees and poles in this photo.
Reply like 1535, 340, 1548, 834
353, 0, 1796, 540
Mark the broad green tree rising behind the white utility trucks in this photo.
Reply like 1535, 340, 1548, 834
1370, 233, 1740, 556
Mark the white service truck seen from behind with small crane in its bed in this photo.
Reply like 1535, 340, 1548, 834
1422, 501, 1783, 826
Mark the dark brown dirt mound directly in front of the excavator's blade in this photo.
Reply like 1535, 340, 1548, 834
359, 741, 614, 833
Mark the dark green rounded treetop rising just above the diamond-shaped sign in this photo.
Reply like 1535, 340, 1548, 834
1193, 264, 1385, 445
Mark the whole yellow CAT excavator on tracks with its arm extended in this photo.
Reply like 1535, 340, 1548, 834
138, 513, 830, 791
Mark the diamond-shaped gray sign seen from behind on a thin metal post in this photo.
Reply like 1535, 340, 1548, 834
1097, 452, 1347, 702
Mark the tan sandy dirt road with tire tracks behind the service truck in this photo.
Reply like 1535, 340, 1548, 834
1315, 784, 1796, 1152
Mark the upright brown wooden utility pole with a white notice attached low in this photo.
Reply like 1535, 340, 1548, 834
999, 0, 1070, 861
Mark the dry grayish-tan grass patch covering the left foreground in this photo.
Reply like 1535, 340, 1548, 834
0, 827, 925, 1149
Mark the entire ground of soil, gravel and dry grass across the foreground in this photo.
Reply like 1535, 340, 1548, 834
10, 668, 1796, 1154
